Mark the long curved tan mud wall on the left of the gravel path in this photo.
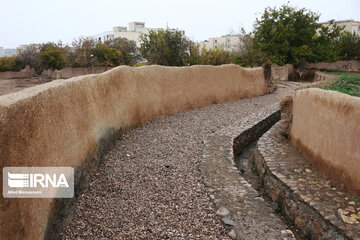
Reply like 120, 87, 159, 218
0, 65, 271, 239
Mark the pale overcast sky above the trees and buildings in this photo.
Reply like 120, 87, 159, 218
0, 0, 360, 48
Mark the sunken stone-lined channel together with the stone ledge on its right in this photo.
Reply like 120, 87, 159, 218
234, 117, 360, 240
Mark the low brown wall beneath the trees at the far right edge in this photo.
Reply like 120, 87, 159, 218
304, 61, 360, 72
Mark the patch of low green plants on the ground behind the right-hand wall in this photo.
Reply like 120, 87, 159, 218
323, 73, 360, 97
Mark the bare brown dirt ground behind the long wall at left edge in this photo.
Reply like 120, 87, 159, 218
0, 78, 51, 95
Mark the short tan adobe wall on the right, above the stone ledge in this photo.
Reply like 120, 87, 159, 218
290, 88, 360, 194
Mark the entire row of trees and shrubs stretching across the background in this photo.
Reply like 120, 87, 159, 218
0, 5, 360, 74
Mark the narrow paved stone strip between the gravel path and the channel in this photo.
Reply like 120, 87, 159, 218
199, 104, 294, 240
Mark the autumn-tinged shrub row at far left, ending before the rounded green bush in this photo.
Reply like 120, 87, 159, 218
0, 38, 140, 72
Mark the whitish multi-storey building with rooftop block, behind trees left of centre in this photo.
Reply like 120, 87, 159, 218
93, 22, 185, 47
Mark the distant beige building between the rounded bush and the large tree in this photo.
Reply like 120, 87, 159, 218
200, 34, 241, 52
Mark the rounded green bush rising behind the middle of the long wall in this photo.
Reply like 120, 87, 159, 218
140, 30, 189, 66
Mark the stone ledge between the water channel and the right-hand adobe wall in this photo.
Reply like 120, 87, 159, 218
255, 124, 360, 240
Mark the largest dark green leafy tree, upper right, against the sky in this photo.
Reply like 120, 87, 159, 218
254, 5, 341, 65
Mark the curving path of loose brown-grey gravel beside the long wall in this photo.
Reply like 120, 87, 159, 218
61, 83, 300, 239
